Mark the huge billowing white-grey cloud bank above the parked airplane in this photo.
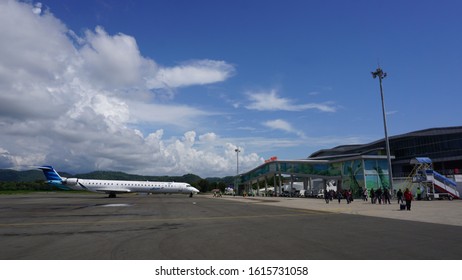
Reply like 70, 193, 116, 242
0, 1, 261, 176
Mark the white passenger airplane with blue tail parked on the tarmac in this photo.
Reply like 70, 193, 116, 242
39, 165, 199, 198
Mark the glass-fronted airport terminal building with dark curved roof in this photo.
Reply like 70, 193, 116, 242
239, 126, 462, 197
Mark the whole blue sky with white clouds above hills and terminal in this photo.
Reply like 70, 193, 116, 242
0, 0, 462, 176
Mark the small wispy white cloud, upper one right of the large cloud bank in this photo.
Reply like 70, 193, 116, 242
246, 89, 336, 112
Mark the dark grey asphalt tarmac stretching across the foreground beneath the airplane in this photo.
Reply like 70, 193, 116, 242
0, 192, 462, 260
